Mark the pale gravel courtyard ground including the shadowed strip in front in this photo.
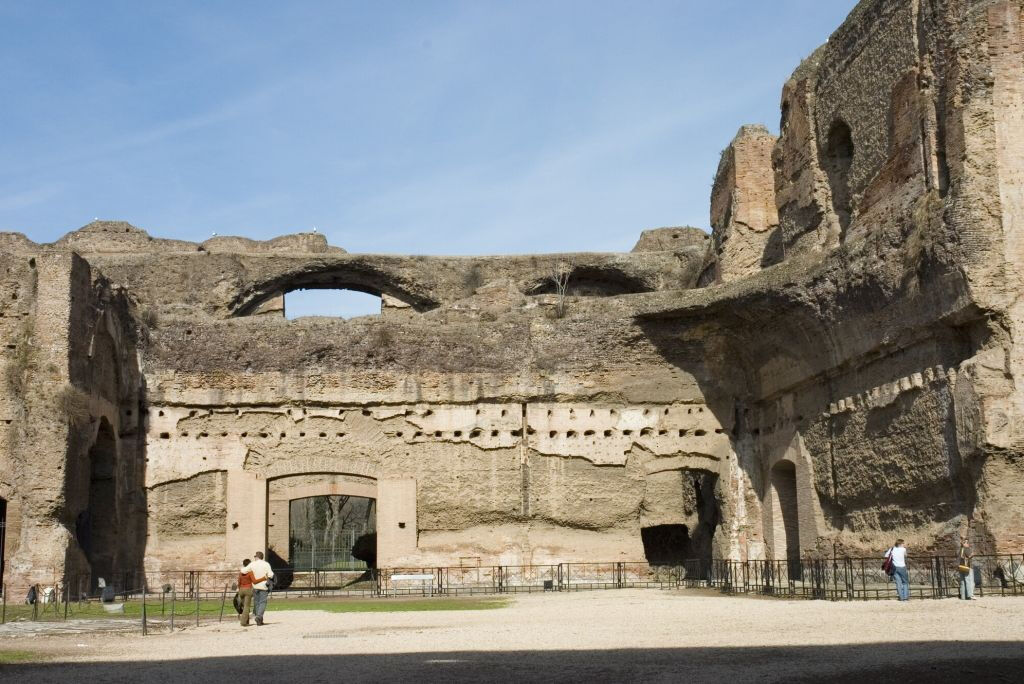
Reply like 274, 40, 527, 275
0, 590, 1024, 684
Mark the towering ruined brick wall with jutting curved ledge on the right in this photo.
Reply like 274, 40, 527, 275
663, 0, 1024, 552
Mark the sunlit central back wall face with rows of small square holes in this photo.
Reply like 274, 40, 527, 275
138, 299, 730, 564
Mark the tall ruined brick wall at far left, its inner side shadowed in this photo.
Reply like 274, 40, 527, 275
0, 241, 145, 583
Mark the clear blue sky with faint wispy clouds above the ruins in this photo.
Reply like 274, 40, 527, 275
0, 0, 855, 317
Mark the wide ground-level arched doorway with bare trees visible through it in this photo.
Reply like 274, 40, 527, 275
288, 495, 377, 571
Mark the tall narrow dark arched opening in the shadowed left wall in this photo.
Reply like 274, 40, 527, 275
82, 418, 122, 585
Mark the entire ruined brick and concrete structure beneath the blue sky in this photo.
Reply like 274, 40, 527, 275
0, 0, 1024, 582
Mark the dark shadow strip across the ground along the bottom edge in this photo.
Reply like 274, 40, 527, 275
0, 643, 1024, 684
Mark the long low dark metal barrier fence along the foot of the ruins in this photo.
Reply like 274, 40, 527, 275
0, 554, 1024, 632
